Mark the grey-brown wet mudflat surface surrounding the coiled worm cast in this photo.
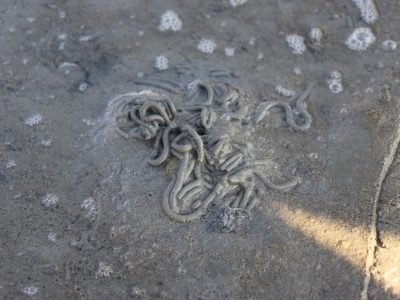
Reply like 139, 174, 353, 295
0, 0, 400, 299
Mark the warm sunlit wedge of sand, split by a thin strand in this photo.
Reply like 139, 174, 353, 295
272, 202, 400, 296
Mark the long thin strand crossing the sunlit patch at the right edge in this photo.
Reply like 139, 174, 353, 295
360, 115, 400, 300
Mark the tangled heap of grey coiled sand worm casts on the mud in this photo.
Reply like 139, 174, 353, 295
110, 80, 312, 222
